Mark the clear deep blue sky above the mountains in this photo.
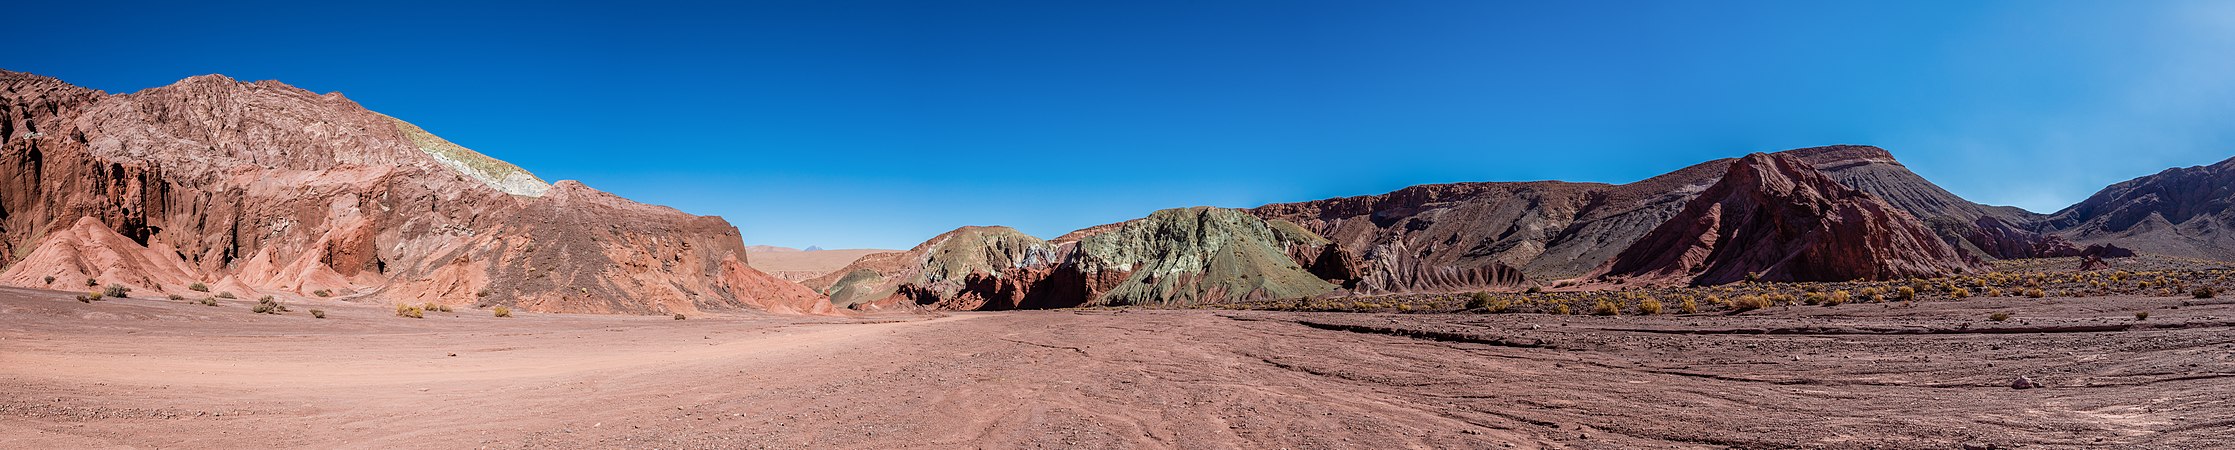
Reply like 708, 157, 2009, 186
0, 0, 2235, 249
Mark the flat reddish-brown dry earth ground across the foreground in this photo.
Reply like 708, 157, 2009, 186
0, 289, 2235, 448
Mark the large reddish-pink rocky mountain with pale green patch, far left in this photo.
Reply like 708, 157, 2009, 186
0, 72, 831, 313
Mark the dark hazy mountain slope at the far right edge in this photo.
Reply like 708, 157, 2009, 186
2049, 159, 2235, 260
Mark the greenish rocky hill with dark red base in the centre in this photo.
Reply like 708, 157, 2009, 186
807, 208, 1357, 311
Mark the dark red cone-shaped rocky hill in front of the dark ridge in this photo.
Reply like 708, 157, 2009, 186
1607, 154, 1980, 284
